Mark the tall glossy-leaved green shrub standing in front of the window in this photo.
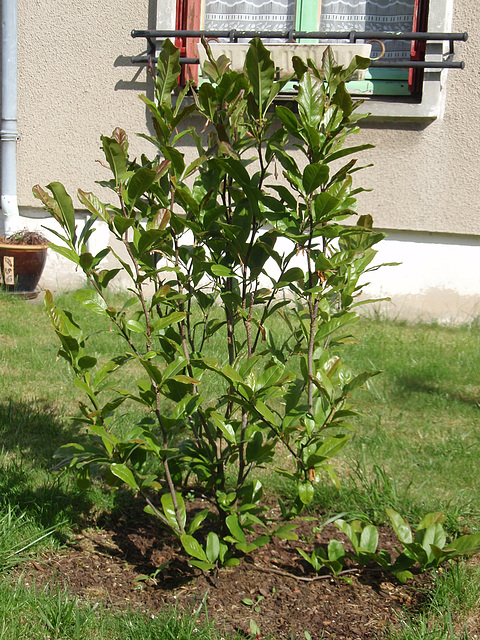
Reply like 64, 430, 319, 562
34, 40, 382, 570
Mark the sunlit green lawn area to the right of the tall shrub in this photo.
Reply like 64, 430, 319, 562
312, 321, 480, 530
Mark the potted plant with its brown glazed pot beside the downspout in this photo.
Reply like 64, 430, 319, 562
0, 229, 48, 297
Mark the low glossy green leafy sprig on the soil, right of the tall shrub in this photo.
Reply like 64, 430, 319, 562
297, 509, 480, 582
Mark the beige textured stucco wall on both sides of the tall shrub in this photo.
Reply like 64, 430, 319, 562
4, 0, 480, 314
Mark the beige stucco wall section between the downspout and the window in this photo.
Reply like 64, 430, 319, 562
18, 0, 156, 207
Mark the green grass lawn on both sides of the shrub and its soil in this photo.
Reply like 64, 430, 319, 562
0, 295, 480, 640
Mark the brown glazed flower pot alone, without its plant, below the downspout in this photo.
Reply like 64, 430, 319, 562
0, 243, 47, 293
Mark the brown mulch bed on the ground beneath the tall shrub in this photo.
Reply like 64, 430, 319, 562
18, 500, 429, 640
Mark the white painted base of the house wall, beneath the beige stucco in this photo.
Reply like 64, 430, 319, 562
14, 210, 480, 324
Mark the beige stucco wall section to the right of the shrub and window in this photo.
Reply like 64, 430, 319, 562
352, 0, 480, 235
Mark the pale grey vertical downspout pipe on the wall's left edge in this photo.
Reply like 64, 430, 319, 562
0, 0, 20, 235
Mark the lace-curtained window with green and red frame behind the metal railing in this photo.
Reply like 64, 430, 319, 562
177, 0, 428, 95
